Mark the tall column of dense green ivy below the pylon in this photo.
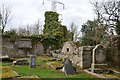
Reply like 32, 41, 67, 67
42, 11, 67, 49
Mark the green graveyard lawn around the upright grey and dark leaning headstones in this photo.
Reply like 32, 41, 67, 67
0, 56, 101, 78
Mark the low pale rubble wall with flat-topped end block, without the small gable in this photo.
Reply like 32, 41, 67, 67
52, 46, 93, 69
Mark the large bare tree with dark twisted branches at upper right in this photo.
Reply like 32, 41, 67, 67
91, 0, 119, 34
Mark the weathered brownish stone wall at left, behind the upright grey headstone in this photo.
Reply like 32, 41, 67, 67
0, 37, 44, 58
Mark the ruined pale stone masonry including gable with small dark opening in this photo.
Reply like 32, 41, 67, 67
52, 42, 94, 69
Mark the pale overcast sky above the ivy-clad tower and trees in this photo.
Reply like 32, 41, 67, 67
0, 0, 95, 29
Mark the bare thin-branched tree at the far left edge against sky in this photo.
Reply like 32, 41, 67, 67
0, 5, 12, 34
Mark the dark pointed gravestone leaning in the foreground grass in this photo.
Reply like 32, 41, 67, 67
62, 58, 76, 75
